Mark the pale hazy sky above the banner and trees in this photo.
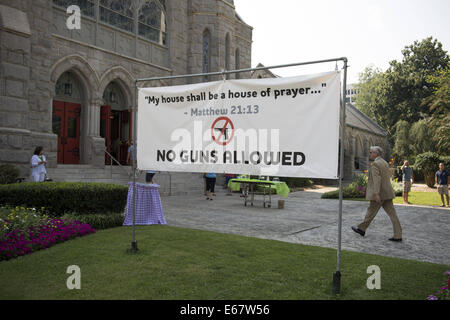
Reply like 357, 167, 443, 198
234, 0, 450, 83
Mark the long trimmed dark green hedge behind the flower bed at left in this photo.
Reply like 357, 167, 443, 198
0, 182, 128, 217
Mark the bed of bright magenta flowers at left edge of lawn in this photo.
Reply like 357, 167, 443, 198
0, 219, 95, 261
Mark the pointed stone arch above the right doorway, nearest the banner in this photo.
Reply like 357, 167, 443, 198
98, 66, 134, 107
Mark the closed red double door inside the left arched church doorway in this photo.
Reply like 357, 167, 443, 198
52, 101, 81, 164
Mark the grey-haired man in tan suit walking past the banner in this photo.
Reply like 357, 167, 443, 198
352, 146, 402, 241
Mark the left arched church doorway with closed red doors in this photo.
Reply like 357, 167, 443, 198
52, 71, 82, 164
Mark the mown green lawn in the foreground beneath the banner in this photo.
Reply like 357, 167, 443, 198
0, 225, 449, 300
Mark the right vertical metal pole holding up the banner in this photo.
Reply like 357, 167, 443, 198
333, 58, 347, 294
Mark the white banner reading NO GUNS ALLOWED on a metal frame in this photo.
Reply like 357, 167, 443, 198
137, 72, 340, 179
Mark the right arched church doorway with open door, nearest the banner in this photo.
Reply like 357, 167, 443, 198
100, 81, 132, 165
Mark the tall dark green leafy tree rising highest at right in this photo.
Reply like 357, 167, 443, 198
356, 37, 450, 143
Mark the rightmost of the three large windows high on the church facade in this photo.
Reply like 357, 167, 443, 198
138, 0, 166, 45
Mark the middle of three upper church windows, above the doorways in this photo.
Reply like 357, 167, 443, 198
100, 0, 134, 32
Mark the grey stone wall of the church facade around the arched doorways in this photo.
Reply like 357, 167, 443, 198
0, 0, 252, 188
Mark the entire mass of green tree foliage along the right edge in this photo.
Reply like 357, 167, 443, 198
355, 37, 450, 165
